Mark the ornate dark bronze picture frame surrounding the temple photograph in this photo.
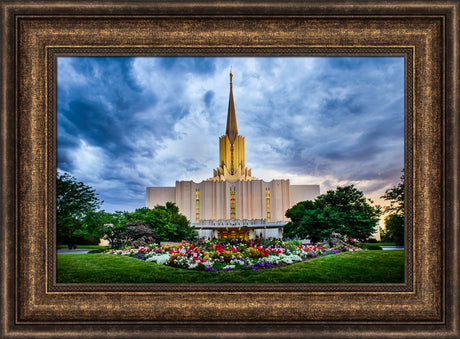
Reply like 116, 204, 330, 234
0, 1, 460, 338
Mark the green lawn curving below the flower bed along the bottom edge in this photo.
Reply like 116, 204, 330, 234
57, 250, 404, 283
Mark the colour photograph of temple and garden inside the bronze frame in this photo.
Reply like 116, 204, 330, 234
52, 55, 406, 289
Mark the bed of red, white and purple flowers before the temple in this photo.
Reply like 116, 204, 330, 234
108, 241, 359, 272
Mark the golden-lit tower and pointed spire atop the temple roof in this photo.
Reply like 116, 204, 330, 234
208, 70, 257, 182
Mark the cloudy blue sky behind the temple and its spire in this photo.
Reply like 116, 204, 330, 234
57, 57, 404, 212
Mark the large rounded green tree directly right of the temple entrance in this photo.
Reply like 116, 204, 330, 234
284, 185, 381, 242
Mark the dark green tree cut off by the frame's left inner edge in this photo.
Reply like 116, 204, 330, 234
56, 173, 102, 247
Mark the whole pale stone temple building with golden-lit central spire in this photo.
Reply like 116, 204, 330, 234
146, 73, 319, 239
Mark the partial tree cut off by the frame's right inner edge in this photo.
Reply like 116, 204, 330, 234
381, 170, 404, 245
